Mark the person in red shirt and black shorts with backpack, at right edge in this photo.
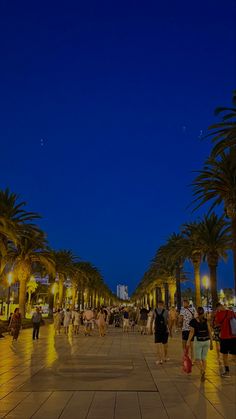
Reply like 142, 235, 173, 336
215, 303, 236, 378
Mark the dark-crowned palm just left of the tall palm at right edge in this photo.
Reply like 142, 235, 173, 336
198, 213, 231, 308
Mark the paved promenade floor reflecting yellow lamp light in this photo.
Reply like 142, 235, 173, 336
0, 325, 235, 419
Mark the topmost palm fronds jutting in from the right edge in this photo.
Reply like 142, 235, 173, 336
208, 90, 236, 157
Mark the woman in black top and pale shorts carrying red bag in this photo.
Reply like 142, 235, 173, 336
186, 307, 213, 381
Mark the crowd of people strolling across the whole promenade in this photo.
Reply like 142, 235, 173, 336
6, 300, 236, 381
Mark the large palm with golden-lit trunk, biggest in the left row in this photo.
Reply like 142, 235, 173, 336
3, 226, 54, 317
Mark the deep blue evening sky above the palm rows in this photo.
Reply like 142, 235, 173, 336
0, 0, 236, 296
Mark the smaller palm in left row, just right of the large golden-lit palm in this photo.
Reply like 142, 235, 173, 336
51, 249, 78, 306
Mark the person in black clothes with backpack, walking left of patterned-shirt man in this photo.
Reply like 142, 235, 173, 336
153, 301, 169, 365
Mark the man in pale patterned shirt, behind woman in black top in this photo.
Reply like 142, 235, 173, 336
179, 300, 196, 363
